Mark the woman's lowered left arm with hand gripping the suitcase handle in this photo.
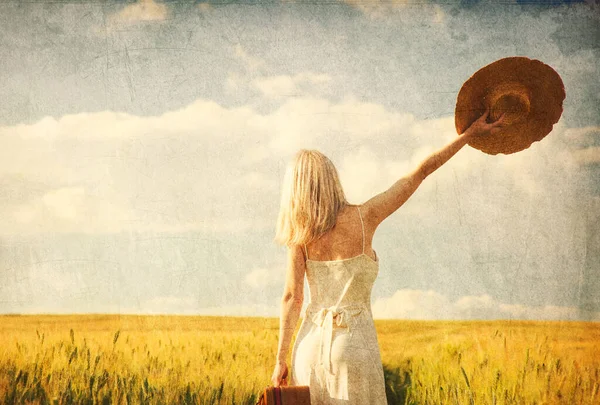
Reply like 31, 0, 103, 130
271, 246, 306, 387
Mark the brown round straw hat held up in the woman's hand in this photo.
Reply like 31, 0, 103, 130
454, 56, 565, 155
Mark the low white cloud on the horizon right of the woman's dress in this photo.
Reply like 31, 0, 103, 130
372, 289, 600, 321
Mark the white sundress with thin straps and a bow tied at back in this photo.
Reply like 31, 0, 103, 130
290, 208, 387, 405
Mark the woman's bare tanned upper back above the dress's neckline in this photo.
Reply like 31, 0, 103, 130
304, 205, 377, 261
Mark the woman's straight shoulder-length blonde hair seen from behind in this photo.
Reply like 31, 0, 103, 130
275, 149, 348, 246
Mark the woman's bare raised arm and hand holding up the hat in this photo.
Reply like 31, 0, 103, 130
363, 111, 504, 231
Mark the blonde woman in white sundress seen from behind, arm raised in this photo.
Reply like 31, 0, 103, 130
272, 112, 503, 405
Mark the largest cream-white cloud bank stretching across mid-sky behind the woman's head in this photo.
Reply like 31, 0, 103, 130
0, 94, 592, 246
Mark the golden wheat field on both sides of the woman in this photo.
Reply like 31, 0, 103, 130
0, 315, 600, 405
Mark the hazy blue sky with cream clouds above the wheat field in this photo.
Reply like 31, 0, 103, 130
0, 0, 600, 321
